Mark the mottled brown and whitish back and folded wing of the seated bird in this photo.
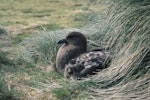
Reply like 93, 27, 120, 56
64, 51, 109, 77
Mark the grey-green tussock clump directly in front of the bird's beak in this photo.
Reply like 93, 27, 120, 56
14, 32, 58, 66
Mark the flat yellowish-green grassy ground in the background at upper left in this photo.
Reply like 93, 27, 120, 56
0, 0, 105, 34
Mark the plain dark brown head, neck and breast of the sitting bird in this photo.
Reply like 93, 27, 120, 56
56, 32, 87, 74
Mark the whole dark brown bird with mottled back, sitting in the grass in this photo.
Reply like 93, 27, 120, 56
56, 32, 108, 78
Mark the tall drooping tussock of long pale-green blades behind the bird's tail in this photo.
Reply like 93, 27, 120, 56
60, 0, 150, 100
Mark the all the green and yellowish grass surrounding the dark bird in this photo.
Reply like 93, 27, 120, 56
0, 0, 150, 100
